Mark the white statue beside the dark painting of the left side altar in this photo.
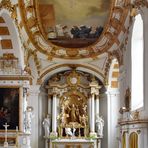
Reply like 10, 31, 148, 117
25, 106, 34, 134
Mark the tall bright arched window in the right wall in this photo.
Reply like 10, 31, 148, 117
131, 14, 144, 110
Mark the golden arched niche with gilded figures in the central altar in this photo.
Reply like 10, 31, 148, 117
59, 90, 89, 138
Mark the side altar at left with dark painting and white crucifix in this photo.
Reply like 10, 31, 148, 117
0, 53, 33, 148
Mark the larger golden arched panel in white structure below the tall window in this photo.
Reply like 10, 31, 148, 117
129, 132, 138, 148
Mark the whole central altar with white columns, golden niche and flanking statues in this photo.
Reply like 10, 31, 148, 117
43, 70, 104, 148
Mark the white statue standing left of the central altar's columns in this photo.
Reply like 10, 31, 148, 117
43, 114, 50, 137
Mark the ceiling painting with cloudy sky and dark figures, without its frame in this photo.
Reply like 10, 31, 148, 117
38, 0, 111, 48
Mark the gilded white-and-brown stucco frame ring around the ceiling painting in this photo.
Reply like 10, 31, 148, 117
19, 0, 129, 60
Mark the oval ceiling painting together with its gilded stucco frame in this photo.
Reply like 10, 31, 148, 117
19, 0, 129, 59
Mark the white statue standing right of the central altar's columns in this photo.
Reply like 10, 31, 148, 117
96, 115, 104, 137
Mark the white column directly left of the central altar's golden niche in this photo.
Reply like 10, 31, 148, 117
52, 93, 57, 134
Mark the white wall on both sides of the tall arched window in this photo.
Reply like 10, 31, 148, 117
122, 8, 148, 118
